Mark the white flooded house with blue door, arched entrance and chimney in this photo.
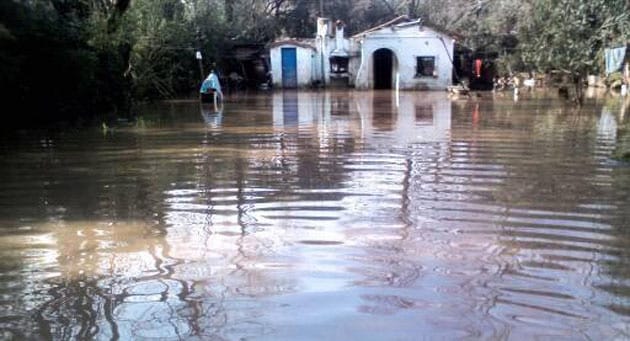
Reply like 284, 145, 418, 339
270, 16, 455, 90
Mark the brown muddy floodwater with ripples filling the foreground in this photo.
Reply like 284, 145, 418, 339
0, 92, 630, 340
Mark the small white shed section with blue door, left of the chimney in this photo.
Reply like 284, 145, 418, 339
269, 39, 316, 88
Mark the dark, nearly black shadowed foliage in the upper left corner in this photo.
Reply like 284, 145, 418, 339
0, 0, 131, 126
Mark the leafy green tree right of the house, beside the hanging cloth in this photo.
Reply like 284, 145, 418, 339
520, 0, 630, 104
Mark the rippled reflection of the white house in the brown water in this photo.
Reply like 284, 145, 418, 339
273, 91, 452, 145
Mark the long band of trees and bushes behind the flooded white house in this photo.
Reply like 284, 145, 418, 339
0, 0, 630, 125
